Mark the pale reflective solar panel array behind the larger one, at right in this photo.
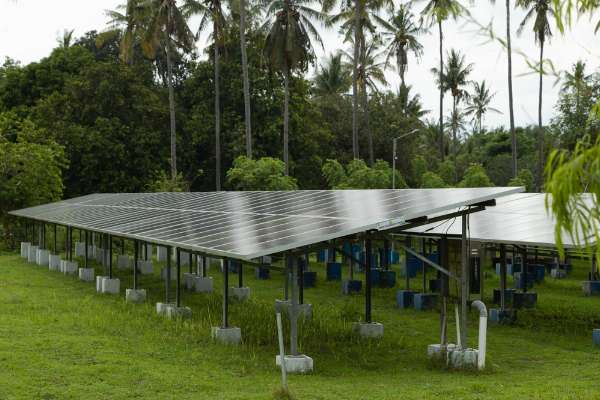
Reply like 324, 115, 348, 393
406, 193, 597, 248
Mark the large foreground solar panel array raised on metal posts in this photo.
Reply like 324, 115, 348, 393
11, 188, 522, 260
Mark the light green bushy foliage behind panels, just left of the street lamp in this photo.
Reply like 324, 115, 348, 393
323, 160, 406, 189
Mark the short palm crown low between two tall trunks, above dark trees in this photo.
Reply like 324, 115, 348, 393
313, 52, 352, 97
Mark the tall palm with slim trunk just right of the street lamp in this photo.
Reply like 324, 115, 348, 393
421, 0, 465, 160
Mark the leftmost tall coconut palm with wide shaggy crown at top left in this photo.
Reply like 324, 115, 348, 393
108, 0, 194, 181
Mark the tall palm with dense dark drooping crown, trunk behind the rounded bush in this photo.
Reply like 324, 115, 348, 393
264, 0, 325, 175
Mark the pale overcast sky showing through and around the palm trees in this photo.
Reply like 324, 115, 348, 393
0, 0, 600, 126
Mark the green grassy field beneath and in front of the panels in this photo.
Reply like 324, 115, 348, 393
0, 253, 600, 399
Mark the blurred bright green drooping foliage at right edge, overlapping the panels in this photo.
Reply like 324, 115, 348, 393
545, 137, 600, 255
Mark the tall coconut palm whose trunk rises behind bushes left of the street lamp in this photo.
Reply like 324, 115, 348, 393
322, 0, 392, 159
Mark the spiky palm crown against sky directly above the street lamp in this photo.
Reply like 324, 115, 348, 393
375, 3, 423, 85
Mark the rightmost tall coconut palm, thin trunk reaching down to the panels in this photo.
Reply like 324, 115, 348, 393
516, 0, 556, 189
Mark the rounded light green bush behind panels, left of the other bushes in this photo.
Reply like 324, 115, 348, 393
227, 156, 298, 190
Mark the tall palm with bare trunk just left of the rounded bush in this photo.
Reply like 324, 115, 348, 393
183, 0, 227, 191
